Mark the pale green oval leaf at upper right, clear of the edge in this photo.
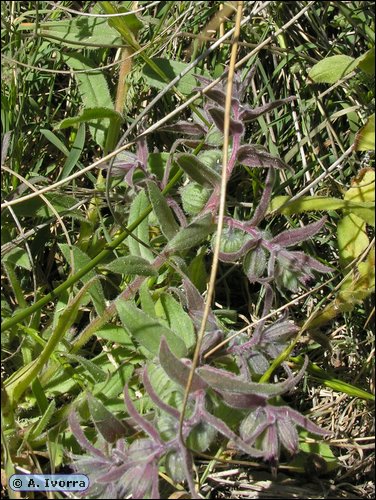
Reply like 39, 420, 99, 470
308, 55, 358, 83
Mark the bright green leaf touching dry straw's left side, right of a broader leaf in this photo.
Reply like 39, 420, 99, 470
155, 293, 196, 350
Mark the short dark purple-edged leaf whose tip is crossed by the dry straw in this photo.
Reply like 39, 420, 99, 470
159, 338, 207, 392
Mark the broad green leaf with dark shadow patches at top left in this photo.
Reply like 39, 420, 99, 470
36, 16, 121, 50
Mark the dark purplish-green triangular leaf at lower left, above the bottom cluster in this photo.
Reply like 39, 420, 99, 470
87, 393, 134, 443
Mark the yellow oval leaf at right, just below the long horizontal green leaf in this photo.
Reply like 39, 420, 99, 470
337, 214, 369, 268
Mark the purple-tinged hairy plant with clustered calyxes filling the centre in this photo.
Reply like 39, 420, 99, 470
70, 70, 330, 498
